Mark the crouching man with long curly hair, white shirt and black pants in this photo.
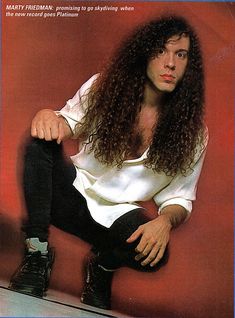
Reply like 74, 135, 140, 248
10, 17, 207, 309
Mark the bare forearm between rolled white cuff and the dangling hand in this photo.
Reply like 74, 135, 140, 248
161, 204, 188, 228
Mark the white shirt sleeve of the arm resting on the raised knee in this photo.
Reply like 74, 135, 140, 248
55, 74, 98, 133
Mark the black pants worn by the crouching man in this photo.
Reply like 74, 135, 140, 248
23, 139, 168, 271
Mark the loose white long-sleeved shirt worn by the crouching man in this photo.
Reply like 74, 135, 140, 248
58, 75, 207, 227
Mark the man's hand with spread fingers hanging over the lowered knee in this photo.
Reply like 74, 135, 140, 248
127, 215, 172, 267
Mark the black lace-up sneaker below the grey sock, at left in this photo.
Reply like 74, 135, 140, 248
9, 248, 55, 297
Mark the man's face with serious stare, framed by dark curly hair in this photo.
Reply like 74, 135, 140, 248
147, 35, 190, 93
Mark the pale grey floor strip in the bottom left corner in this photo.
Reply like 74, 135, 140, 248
0, 282, 130, 318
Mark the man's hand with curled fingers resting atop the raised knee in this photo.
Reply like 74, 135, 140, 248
31, 109, 72, 144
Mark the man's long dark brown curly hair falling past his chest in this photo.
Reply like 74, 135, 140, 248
77, 16, 204, 176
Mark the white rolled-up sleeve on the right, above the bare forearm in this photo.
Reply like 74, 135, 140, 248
153, 135, 208, 215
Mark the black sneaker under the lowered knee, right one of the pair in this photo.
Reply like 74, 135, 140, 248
81, 257, 114, 309
